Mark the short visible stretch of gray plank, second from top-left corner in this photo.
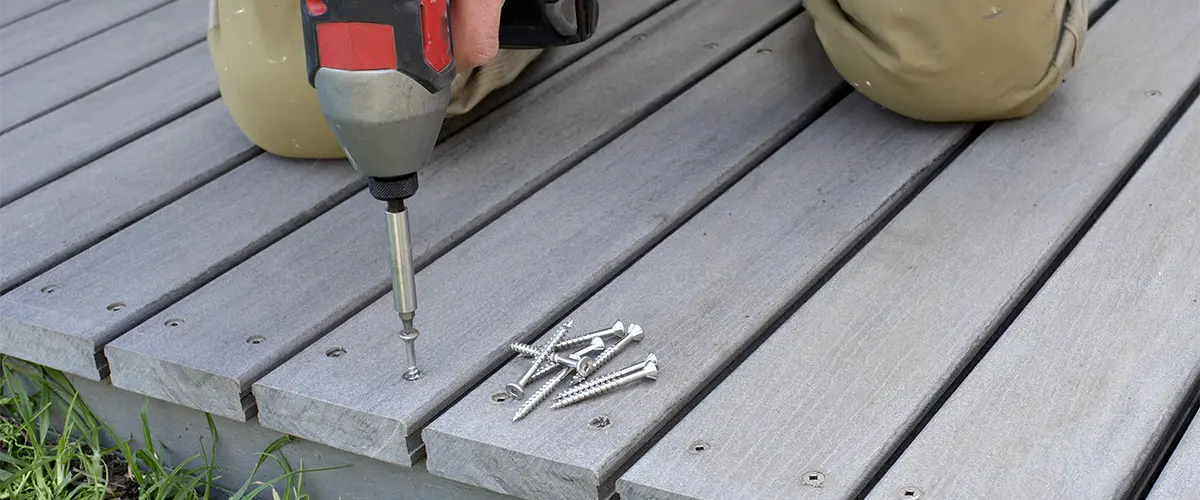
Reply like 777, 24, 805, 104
0, 0, 168, 74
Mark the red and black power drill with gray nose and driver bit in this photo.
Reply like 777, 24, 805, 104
302, 0, 596, 380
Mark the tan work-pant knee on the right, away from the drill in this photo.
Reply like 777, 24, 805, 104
805, 0, 1087, 121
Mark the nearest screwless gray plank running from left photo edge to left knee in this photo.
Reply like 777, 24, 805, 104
0, 101, 258, 290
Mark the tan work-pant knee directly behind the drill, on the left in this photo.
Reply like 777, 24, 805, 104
208, 0, 541, 158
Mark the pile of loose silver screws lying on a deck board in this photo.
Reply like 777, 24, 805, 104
505, 320, 659, 422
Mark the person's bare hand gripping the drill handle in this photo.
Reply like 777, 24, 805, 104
450, 0, 504, 72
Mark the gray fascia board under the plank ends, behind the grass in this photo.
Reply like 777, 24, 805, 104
68, 375, 516, 500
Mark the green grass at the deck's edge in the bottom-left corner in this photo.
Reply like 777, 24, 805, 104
0, 356, 348, 500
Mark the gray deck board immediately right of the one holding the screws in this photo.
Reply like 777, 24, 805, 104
617, 0, 1200, 500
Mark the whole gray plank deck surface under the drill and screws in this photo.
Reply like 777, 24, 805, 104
0, 0, 1200, 500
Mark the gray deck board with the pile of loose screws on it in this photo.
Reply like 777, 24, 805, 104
424, 44, 970, 499
